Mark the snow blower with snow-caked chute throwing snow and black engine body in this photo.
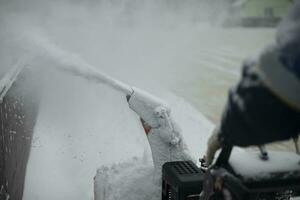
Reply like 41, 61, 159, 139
54, 55, 300, 200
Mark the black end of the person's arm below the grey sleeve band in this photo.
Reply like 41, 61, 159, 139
220, 65, 300, 146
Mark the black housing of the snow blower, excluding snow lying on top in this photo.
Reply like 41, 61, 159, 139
162, 146, 300, 200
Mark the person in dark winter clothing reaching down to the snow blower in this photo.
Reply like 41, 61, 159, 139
204, 1, 300, 165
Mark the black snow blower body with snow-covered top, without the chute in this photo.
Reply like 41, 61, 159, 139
162, 146, 300, 200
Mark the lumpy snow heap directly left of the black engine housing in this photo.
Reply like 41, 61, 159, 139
94, 158, 161, 200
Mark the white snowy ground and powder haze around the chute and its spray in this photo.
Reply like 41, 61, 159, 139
0, 0, 274, 200
